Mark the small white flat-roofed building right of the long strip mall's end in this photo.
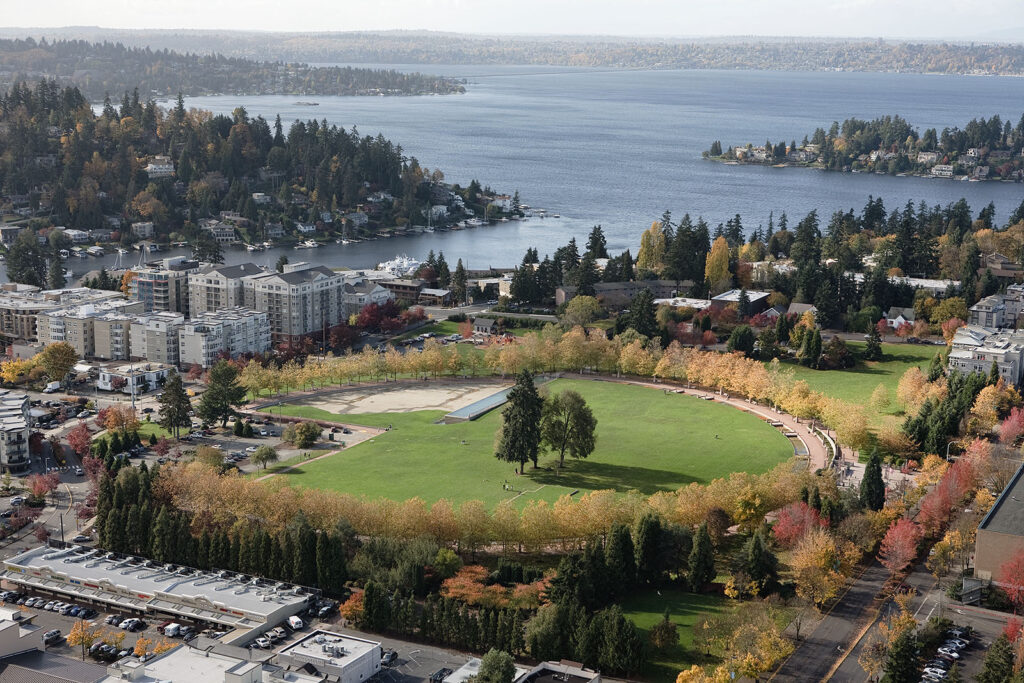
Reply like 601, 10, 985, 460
278, 631, 381, 683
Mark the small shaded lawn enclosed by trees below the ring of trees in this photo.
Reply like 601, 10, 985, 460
621, 588, 733, 681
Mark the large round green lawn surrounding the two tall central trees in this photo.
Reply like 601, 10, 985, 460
266, 380, 793, 506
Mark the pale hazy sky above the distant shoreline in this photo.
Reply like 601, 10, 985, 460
12, 0, 1024, 42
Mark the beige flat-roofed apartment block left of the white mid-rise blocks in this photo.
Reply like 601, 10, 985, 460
36, 295, 142, 358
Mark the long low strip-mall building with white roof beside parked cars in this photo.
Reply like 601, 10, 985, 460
0, 543, 315, 643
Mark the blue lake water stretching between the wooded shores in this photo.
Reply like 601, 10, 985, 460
77, 66, 1024, 271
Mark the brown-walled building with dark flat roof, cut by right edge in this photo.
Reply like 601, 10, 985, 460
974, 458, 1024, 583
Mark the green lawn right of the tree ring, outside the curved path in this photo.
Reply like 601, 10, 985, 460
784, 342, 947, 427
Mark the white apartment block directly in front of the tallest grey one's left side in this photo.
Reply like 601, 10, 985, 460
178, 306, 270, 368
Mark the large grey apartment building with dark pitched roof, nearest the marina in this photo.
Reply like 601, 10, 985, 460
245, 262, 346, 344
